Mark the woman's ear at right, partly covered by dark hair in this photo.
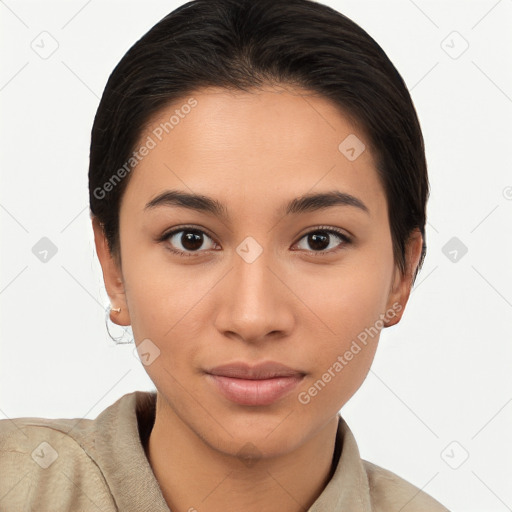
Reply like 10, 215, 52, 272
384, 228, 423, 327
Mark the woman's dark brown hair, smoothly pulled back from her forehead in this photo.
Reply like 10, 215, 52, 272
89, 0, 429, 278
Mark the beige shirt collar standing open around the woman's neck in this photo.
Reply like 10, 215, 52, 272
68, 391, 371, 512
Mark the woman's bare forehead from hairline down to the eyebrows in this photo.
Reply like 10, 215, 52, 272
123, 87, 382, 215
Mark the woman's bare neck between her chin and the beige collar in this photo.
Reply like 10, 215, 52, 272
146, 394, 338, 512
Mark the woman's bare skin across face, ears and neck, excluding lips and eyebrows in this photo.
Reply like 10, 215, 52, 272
93, 87, 422, 512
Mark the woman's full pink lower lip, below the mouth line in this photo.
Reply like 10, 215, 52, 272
207, 374, 304, 405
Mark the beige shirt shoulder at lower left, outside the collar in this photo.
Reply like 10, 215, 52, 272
0, 418, 116, 512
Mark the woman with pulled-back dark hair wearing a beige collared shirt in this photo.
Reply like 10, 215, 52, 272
0, 0, 447, 512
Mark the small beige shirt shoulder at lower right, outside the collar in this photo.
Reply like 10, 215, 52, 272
362, 460, 449, 512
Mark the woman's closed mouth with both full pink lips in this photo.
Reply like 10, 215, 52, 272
206, 362, 306, 406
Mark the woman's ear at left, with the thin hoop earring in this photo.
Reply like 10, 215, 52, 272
91, 215, 130, 325
